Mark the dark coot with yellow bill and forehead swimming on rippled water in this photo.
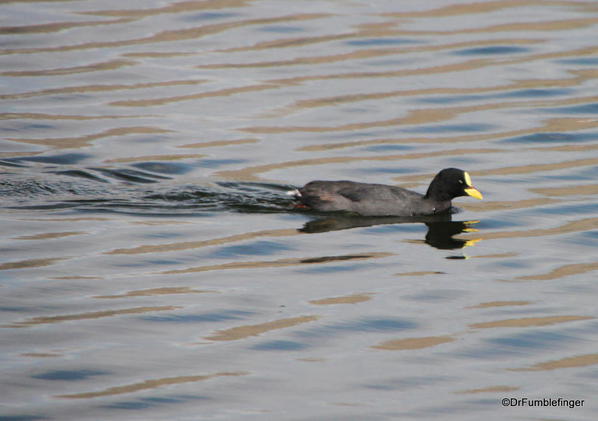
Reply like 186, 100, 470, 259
288, 168, 482, 216
